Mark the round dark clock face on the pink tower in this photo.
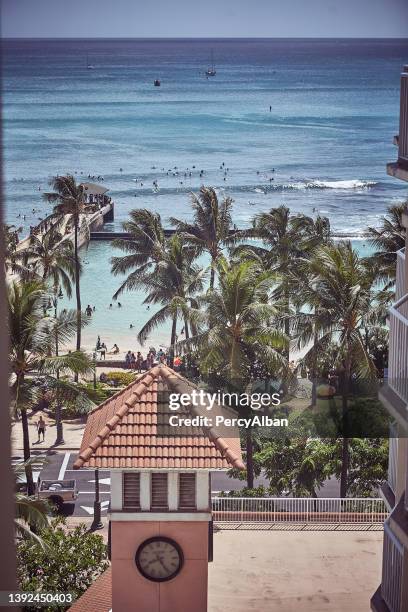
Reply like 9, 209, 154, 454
135, 536, 184, 582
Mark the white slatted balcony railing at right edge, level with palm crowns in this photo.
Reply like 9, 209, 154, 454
388, 294, 408, 402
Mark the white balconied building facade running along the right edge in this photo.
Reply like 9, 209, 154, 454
371, 65, 408, 612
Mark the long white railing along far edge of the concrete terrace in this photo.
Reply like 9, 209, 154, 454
212, 497, 388, 524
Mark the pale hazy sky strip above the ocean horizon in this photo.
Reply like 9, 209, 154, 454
0, 0, 408, 38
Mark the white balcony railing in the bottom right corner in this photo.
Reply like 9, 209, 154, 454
381, 523, 404, 612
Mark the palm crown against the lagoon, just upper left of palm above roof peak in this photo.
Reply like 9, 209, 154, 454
111, 208, 166, 299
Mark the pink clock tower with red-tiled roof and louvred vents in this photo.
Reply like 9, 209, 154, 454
72, 365, 244, 612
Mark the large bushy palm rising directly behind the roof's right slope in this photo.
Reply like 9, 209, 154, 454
185, 259, 287, 488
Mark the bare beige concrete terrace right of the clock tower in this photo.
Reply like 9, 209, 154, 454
209, 531, 383, 612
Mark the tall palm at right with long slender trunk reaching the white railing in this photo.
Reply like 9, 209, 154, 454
292, 242, 377, 497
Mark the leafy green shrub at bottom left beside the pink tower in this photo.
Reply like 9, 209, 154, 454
17, 517, 109, 612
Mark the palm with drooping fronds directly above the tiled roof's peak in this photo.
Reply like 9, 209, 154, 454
138, 234, 205, 358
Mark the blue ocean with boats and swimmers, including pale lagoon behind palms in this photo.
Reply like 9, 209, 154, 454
3, 39, 408, 350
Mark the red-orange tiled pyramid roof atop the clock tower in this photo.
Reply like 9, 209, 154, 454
74, 365, 245, 469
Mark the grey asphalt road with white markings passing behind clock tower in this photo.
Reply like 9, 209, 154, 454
13, 451, 339, 517
